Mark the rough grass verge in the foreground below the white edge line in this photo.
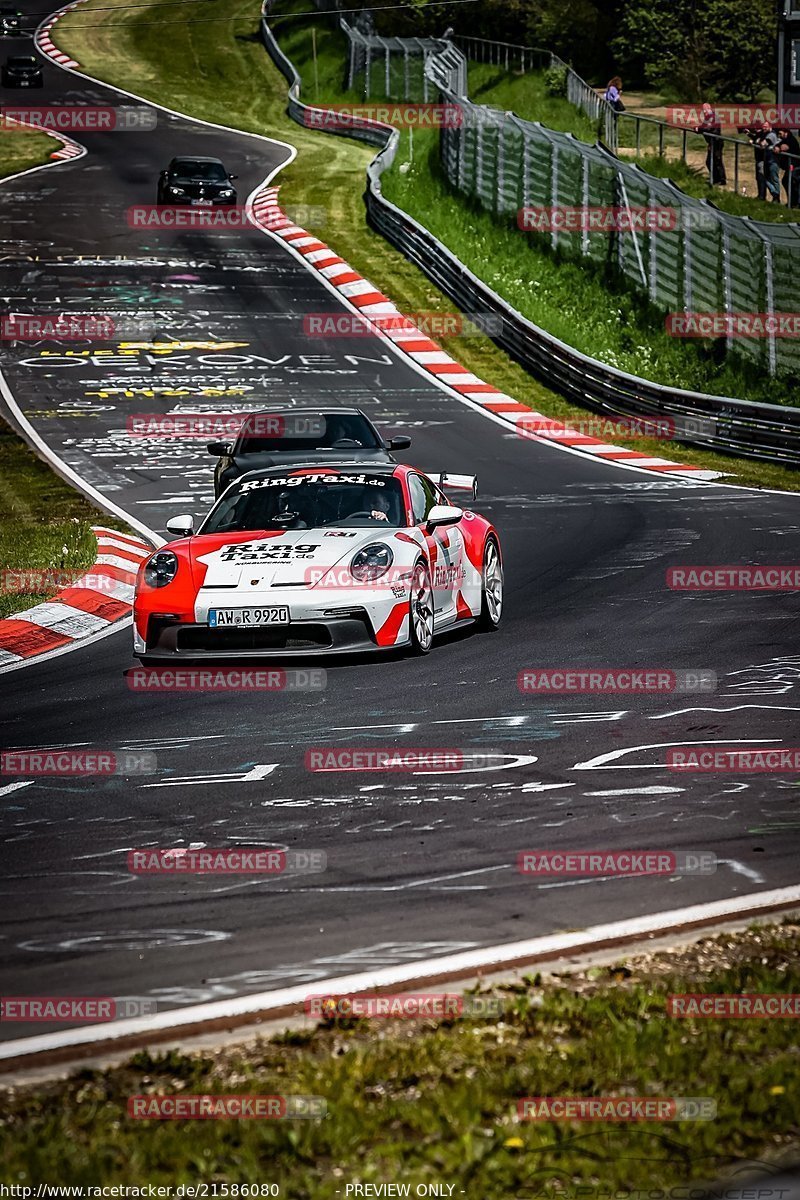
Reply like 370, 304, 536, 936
0, 920, 800, 1200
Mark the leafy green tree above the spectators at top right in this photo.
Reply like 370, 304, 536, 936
612, 0, 776, 102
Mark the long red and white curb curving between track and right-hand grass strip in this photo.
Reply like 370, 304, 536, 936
251, 187, 722, 480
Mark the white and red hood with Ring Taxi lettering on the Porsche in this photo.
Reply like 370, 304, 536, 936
190, 526, 398, 593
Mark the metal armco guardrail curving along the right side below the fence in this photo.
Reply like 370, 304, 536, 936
261, 18, 800, 467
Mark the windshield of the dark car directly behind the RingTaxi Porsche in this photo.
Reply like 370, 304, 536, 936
234, 412, 381, 456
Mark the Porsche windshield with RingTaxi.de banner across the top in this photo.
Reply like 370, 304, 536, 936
199, 474, 405, 533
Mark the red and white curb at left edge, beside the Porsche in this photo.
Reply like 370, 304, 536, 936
0, 526, 152, 667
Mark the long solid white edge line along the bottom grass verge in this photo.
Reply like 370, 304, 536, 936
0, 884, 800, 1060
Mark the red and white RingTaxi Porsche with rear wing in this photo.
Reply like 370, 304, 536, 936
133, 463, 503, 661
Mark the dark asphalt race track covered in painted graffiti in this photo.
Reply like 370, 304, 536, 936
0, 9, 800, 1037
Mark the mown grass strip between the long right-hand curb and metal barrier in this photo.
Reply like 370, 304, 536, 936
56, 0, 799, 491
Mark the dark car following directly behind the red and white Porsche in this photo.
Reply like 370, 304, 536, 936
207, 408, 411, 497
